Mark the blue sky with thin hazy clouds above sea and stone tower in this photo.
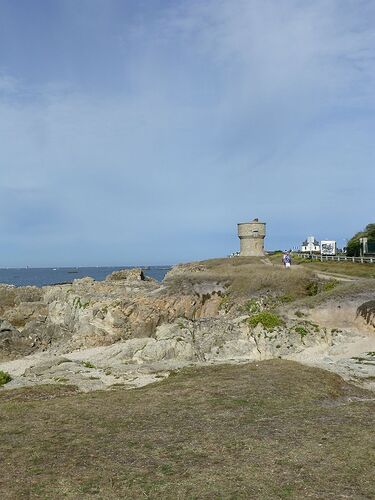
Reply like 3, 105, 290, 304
0, 0, 375, 267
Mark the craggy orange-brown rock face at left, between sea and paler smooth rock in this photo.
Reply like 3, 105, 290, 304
0, 269, 223, 357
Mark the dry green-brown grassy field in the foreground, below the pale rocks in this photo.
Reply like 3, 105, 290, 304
0, 360, 375, 500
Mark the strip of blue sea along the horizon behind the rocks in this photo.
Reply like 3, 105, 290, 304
0, 266, 171, 287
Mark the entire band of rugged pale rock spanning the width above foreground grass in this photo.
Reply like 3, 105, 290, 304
0, 265, 375, 390
